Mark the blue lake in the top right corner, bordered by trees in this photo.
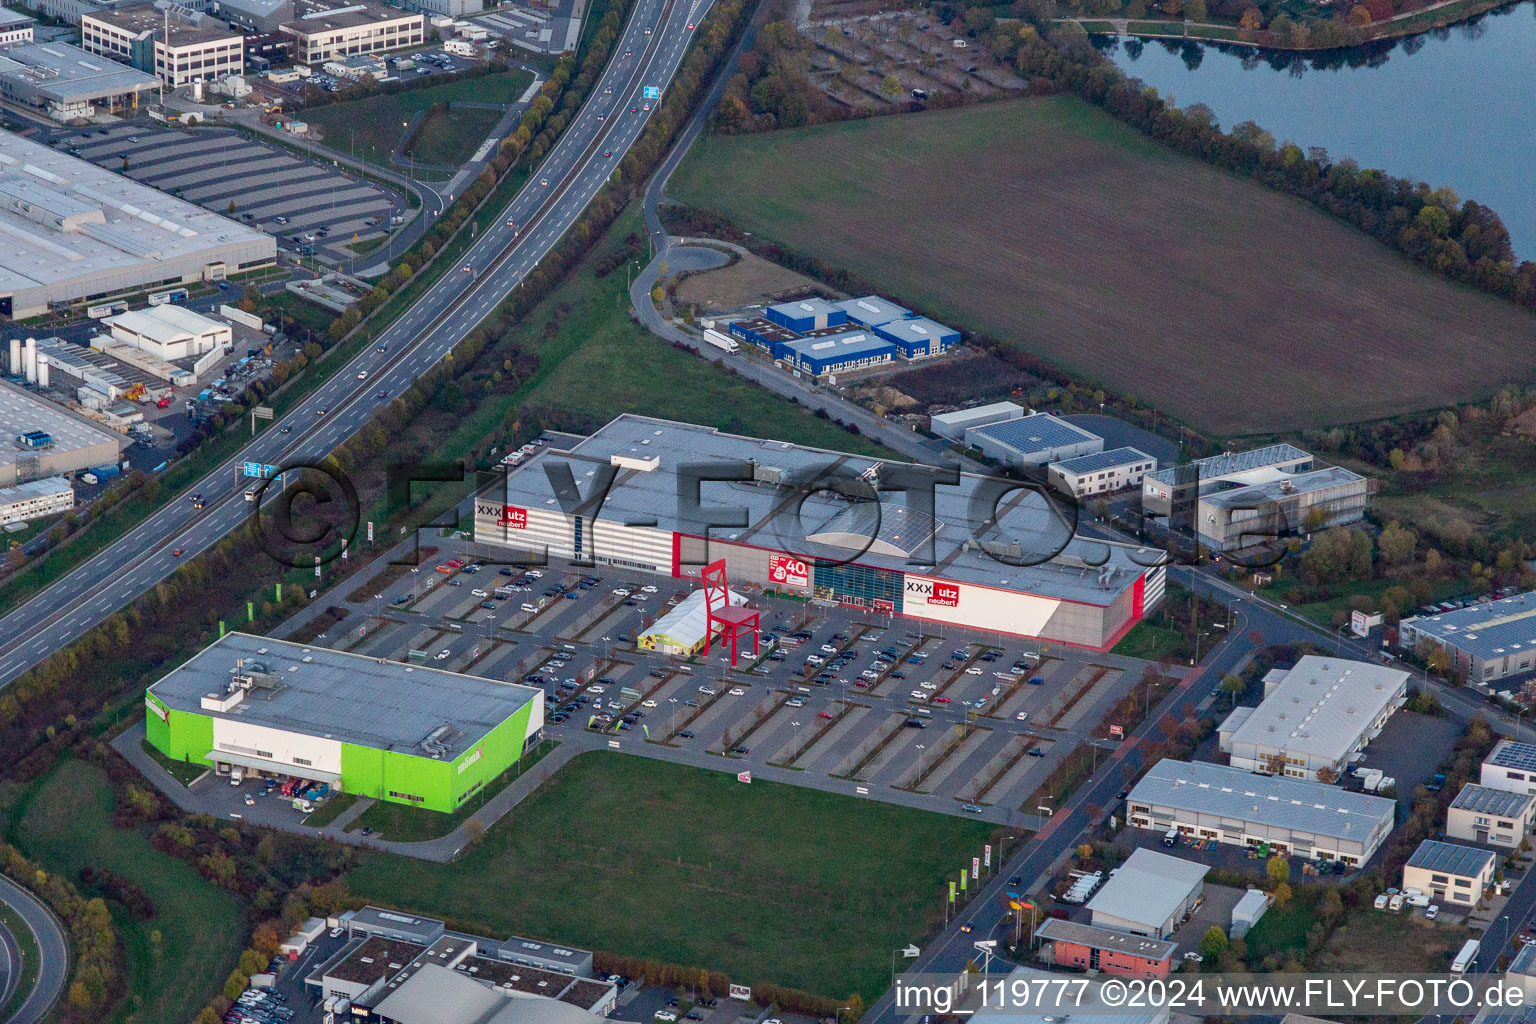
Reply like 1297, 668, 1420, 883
1106, 2, 1536, 259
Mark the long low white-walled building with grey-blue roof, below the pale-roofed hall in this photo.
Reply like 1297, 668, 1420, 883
1126, 757, 1398, 867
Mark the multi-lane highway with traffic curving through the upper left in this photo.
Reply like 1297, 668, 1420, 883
0, 0, 711, 686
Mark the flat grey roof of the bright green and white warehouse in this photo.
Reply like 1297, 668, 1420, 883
149, 633, 544, 760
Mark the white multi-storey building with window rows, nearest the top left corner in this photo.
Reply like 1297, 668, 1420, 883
80, 3, 246, 89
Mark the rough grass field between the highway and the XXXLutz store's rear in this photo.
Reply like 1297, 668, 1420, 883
427, 207, 889, 454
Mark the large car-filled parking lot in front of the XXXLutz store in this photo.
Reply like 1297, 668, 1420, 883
285, 491, 1141, 824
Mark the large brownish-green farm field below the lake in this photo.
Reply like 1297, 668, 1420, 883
670, 97, 1536, 436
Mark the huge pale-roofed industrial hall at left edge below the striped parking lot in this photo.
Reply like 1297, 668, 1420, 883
0, 132, 276, 319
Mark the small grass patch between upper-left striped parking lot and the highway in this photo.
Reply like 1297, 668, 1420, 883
304, 68, 533, 167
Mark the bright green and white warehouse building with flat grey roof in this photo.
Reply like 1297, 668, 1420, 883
144, 633, 544, 811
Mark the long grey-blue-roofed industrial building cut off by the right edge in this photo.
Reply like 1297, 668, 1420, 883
1398, 591, 1536, 684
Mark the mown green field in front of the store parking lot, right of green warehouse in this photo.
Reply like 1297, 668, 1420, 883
347, 752, 989, 1003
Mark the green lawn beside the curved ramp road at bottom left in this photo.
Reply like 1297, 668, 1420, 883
12, 758, 246, 1024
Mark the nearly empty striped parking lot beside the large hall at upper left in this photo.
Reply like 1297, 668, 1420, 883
60, 124, 404, 258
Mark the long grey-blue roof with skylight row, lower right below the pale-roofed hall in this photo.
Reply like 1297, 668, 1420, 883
1129, 757, 1398, 843
